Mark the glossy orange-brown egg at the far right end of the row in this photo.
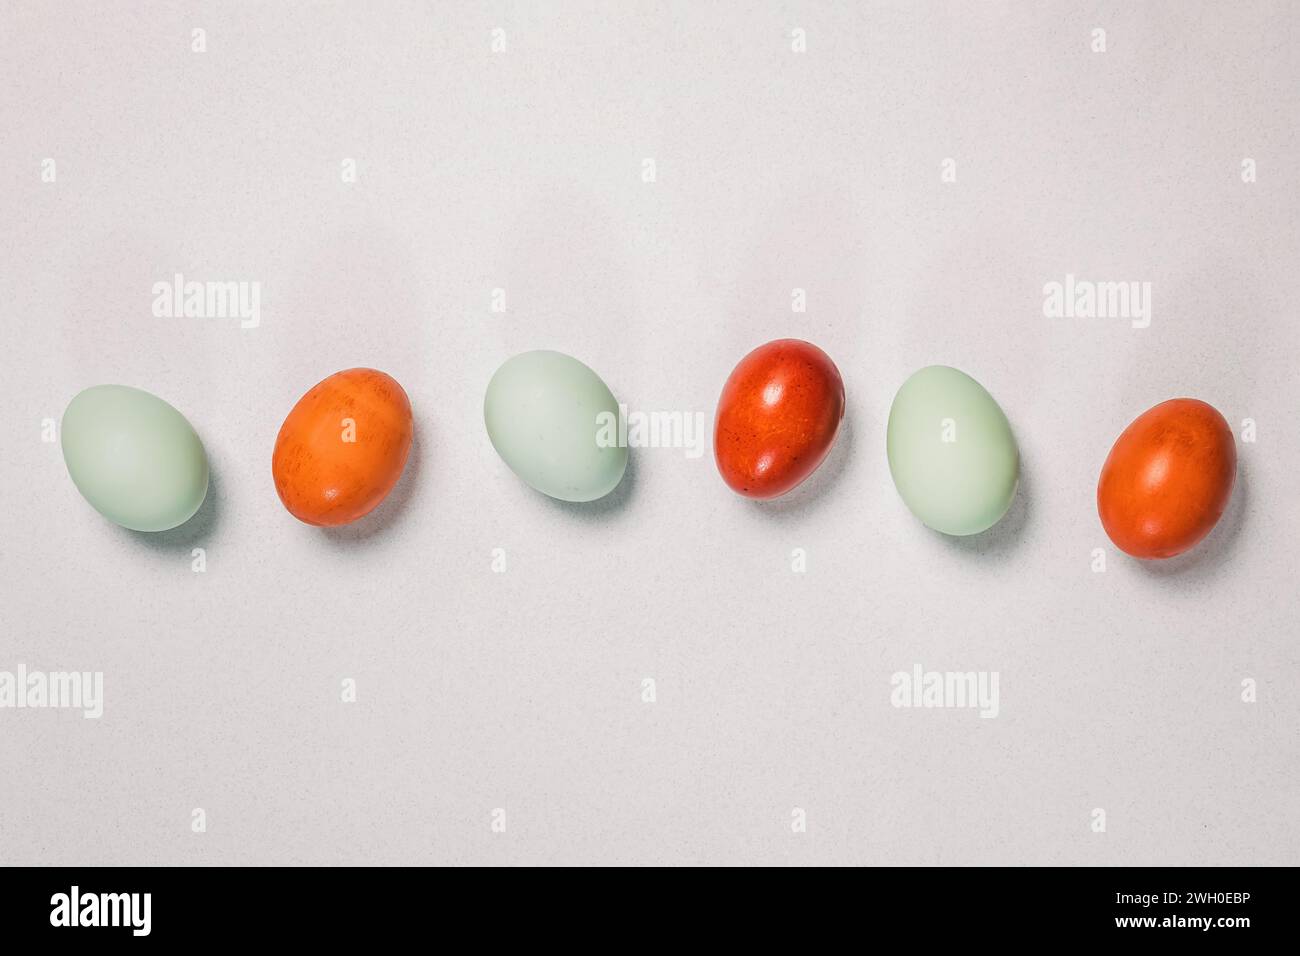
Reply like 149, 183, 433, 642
1097, 398, 1236, 558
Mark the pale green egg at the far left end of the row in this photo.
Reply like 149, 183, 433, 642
60, 385, 208, 531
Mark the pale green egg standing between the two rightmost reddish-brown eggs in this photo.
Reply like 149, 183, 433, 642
885, 365, 1021, 536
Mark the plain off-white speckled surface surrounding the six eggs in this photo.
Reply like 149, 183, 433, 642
0, 0, 1300, 864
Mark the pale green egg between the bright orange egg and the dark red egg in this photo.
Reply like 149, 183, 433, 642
484, 350, 628, 501
